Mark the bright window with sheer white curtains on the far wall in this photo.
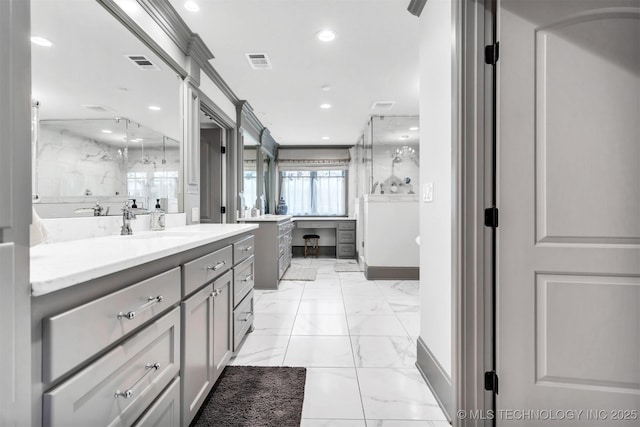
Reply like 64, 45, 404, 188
280, 169, 347, 216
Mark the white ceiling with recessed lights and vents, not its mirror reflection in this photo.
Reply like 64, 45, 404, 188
170, 0, 419, 145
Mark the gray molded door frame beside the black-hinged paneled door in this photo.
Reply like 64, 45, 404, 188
451, 0, 495, 426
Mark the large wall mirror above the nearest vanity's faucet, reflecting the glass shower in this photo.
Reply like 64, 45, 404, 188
31, 0, 183, 217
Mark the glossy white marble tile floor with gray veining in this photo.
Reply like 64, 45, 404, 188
230, 258, 449, 427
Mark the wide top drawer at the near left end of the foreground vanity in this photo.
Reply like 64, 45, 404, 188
42, 267, 180, 382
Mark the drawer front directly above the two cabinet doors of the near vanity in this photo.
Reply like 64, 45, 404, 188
182, 245, 233, 296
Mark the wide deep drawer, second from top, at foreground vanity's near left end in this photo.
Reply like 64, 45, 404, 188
43, 308, 180, 426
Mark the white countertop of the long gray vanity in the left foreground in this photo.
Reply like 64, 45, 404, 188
31, 224, 258, 296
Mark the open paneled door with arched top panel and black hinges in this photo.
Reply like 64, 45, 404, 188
496, 0, 640, 427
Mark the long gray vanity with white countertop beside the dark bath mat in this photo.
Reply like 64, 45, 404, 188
31, 224, 257, 426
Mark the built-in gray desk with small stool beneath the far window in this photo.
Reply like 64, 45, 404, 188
293, 217, 356, 258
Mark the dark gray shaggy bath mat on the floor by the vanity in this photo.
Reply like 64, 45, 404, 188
191, 366, 307, 427
